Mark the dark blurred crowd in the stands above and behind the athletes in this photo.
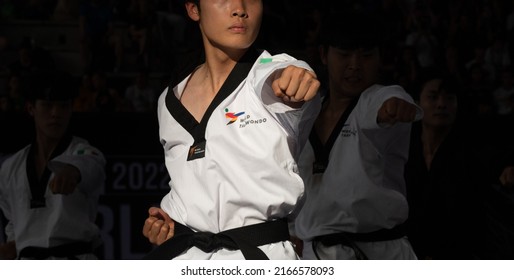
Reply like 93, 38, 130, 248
0, 0, 514, 117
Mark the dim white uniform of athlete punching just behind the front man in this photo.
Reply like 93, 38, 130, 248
295, 85, 422, 259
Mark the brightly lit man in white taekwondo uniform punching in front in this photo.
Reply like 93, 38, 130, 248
143, 0, 320, 259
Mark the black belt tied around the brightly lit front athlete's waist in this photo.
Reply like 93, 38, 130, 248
143, 219, 289, 260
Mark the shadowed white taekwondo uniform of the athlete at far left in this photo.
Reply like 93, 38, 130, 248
0, 137, 105, 259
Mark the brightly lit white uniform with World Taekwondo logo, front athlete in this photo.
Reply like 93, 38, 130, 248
158, 49, 320, 259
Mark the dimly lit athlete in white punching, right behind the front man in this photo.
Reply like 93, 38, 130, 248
295, 10, 422, 259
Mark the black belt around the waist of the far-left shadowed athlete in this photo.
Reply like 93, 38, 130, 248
18, 242, 93, 260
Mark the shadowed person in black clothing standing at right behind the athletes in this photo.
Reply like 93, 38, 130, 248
405, 73, 486, 260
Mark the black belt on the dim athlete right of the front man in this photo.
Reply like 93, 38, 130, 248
312, 224, 406, 260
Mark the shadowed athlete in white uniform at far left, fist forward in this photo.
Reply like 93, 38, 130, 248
0, 71, 105, 259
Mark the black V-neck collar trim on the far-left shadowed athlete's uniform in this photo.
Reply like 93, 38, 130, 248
26, 134, 73, 208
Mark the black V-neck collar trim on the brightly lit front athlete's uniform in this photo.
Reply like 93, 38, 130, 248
166, 48, 260, 145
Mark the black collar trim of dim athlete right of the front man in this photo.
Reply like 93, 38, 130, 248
309, 98, 359, 173
